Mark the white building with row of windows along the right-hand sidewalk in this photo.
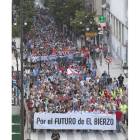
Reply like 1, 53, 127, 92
102, 0, 128, 66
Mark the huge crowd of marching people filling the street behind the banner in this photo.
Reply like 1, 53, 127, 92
12, 8, 128, 132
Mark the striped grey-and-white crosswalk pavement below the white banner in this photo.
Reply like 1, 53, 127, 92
24, 132, 126, 140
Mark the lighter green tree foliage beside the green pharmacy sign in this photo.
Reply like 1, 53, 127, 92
70, 11, 98, 34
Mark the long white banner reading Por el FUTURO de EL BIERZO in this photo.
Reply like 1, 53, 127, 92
34, 113, 116, 130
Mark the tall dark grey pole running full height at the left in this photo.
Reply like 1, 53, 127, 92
20, 0, 24, 140
